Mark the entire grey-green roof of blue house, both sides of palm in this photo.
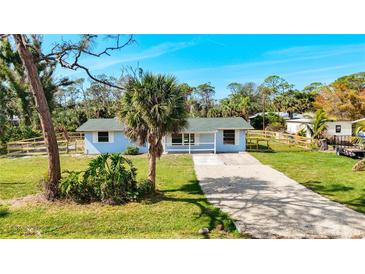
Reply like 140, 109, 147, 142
76, 117, 253, 132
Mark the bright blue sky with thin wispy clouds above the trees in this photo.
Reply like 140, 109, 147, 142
44, 34, 365, 98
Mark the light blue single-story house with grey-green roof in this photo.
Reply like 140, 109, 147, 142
76, 117, 253, 154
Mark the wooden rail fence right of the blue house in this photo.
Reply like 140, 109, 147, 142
246, 130, 313, 149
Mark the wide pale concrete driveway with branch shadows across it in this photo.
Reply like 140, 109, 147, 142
193, 153, 365, 238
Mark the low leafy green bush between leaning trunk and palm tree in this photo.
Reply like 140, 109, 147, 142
60, 153, 138, 204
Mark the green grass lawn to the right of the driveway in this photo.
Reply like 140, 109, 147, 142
250, 143, 365, 213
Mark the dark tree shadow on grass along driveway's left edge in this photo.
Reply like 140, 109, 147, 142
141, 180, 236, 238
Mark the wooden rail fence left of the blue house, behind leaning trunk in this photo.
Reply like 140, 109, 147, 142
7, 132, 84, 156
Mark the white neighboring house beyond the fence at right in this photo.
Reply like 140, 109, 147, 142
286, 119, 353, 137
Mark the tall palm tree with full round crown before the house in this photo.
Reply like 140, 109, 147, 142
119, 73, 187, 189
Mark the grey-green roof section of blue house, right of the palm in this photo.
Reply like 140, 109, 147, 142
184, 117, 253, 132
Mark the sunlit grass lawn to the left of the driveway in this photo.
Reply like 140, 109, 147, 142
0, 155, 242, 238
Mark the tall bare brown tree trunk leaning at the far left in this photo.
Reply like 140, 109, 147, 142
14, 34, 61, 200
